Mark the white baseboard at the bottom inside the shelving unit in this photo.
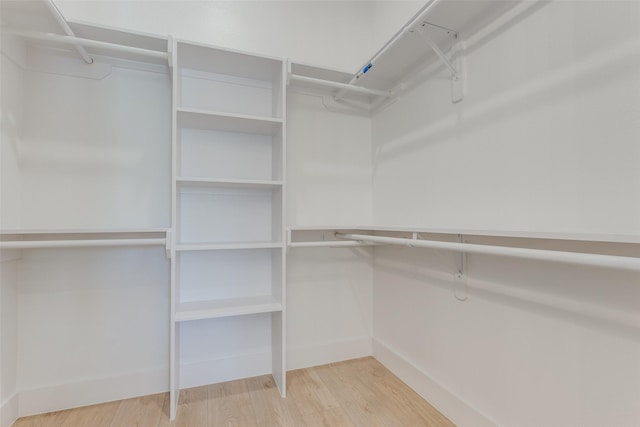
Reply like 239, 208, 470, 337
180, 351, 271, 389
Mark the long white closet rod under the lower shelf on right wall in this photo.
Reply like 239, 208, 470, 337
335, 233, 640, 271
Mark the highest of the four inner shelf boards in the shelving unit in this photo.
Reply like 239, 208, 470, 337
177, 108, 282, 136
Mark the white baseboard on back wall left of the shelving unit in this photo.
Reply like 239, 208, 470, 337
18, 369, 169, 418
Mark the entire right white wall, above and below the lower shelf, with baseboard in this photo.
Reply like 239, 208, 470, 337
373, 1, 640, 426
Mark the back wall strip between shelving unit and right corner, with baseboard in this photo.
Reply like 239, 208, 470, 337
286, 88, 373, 369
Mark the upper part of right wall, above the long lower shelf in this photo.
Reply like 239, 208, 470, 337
373, 1, 640, 234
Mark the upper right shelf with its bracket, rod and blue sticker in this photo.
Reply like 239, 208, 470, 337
290, 0, 520, 102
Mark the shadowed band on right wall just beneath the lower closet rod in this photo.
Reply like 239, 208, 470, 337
374, 247, 640, 341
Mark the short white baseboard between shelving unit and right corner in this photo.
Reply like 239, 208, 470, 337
287, 335, 372, 371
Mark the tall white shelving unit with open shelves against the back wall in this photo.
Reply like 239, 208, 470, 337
170, 41, 285, 419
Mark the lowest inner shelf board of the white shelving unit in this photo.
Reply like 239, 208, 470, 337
175, 295, 282, 322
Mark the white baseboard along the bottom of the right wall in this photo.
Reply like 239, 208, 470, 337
373, 339, 497, 427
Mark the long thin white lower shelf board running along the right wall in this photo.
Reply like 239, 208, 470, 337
288, 225, 640, 244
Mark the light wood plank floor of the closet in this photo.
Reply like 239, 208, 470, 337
14, 357, 453, 427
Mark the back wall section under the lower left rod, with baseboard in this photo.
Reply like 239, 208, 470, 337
18, 248, 169, 416
